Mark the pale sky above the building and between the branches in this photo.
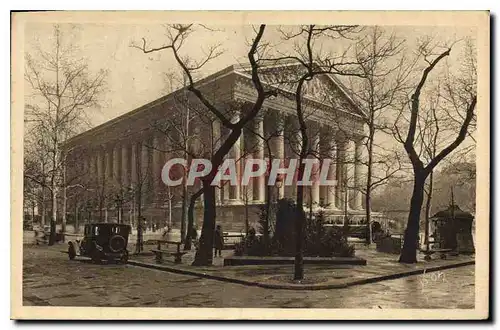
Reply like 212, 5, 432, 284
25, 23, 475, 125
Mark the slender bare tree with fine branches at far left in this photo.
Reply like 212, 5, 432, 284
25, 26, 106, 244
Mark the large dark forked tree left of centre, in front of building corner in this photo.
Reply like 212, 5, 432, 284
134, 24, 276, 266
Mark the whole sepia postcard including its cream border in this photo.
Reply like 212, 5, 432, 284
11, 11, 490, 320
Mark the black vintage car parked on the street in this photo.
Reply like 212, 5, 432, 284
68, 223, 131, 263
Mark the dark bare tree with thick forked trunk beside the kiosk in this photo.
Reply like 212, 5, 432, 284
394, 42, 477, 263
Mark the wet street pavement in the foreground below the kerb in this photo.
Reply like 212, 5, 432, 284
23, 245, 474, 309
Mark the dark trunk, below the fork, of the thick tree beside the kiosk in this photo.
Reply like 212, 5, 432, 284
399, 171, 425, 264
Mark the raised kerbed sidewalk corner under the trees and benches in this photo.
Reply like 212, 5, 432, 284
129, 246, 475, 290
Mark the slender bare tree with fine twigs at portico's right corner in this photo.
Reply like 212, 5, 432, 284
339, 26, 415, 243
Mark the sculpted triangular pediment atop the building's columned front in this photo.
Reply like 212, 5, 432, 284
235, 62, 364, 115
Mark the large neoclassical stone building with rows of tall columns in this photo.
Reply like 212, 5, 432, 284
64, 63, 365, 231
